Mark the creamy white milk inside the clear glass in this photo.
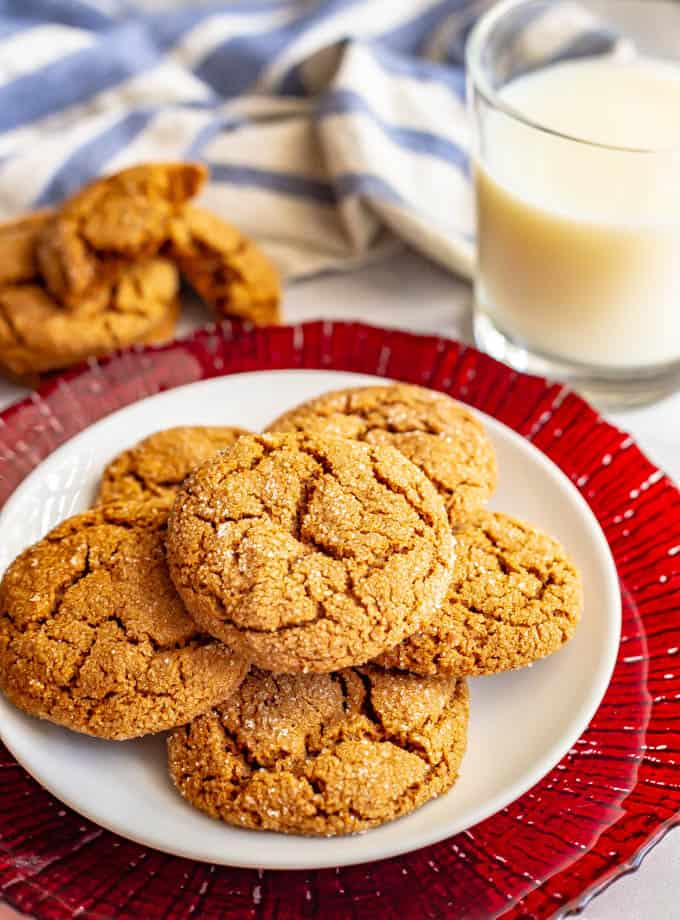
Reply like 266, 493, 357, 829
476, 58, 680, 368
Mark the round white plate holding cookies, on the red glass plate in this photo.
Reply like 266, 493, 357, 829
0, 371, 621, 869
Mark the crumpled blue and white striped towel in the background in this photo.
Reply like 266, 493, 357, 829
0, 0, 620, 277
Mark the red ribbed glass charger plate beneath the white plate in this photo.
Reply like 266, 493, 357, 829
0, 322, 680, 920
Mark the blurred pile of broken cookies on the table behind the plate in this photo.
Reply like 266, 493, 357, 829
0, 163, 280, 384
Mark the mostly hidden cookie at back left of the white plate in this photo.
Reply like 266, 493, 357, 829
97, 425, 249, 504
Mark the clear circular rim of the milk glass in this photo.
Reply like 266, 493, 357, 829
465, 0, 680, 155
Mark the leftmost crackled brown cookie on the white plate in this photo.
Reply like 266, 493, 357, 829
0, 502, 247, 740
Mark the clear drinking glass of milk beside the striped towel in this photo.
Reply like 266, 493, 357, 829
467, 0, 680, 405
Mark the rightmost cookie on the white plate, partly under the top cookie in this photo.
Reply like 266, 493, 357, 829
377, 511, 582, 676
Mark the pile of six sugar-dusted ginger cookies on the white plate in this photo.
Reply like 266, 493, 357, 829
0, 385, 581, 835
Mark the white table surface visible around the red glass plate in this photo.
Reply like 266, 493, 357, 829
0, 252, 680, 920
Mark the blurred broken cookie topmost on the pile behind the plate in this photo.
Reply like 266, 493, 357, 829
37, 163, 207, 307
